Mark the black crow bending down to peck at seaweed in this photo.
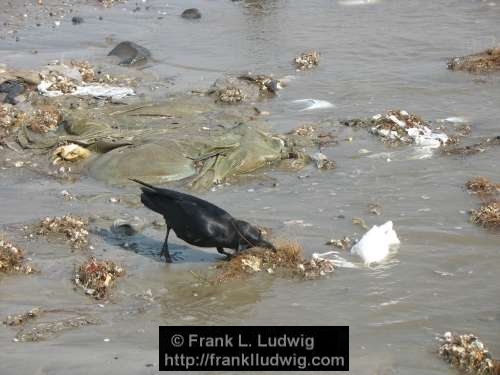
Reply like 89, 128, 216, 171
131, 179, 276, 263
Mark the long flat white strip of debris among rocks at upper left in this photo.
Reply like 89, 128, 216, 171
38, 81, 135, 100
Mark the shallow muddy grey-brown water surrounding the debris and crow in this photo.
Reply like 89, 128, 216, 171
0, 0, 500, 374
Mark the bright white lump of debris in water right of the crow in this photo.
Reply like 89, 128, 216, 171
351, 221, 400, 265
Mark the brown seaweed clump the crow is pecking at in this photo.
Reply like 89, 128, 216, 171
215, 242, 334, 283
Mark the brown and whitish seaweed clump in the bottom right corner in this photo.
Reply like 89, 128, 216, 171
438, 332, 500, 375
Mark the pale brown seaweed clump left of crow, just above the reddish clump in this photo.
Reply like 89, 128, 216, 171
36, 215, 89, 248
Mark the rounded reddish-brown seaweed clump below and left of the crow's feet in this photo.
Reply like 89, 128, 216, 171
73, 257, 125, 299
